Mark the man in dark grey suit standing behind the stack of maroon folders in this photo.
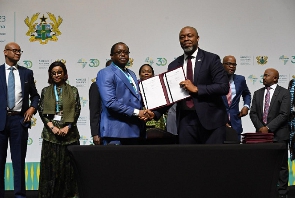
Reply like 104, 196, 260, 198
250, 68, 291, 197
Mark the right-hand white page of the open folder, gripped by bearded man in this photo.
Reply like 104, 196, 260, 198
163, 67, 190, 103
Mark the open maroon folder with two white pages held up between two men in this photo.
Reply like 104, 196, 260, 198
139, 67, 190, 109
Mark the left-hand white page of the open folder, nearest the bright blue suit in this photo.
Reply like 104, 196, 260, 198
139, 76, 167, 109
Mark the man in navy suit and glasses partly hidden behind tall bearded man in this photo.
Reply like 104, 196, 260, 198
222, 56, 251, 140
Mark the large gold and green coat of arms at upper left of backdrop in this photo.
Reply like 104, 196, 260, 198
24, 12, 63, 45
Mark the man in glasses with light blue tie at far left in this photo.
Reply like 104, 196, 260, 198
0, 43, 40, 198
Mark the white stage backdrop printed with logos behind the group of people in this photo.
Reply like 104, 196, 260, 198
0, 0, 295, 162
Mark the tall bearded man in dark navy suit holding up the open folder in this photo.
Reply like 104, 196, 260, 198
154, 27, 229, 144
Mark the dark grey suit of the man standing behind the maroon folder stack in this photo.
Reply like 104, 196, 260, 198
250, 85, 291, 194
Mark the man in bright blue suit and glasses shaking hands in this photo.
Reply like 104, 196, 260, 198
96, 42, 146, 145
